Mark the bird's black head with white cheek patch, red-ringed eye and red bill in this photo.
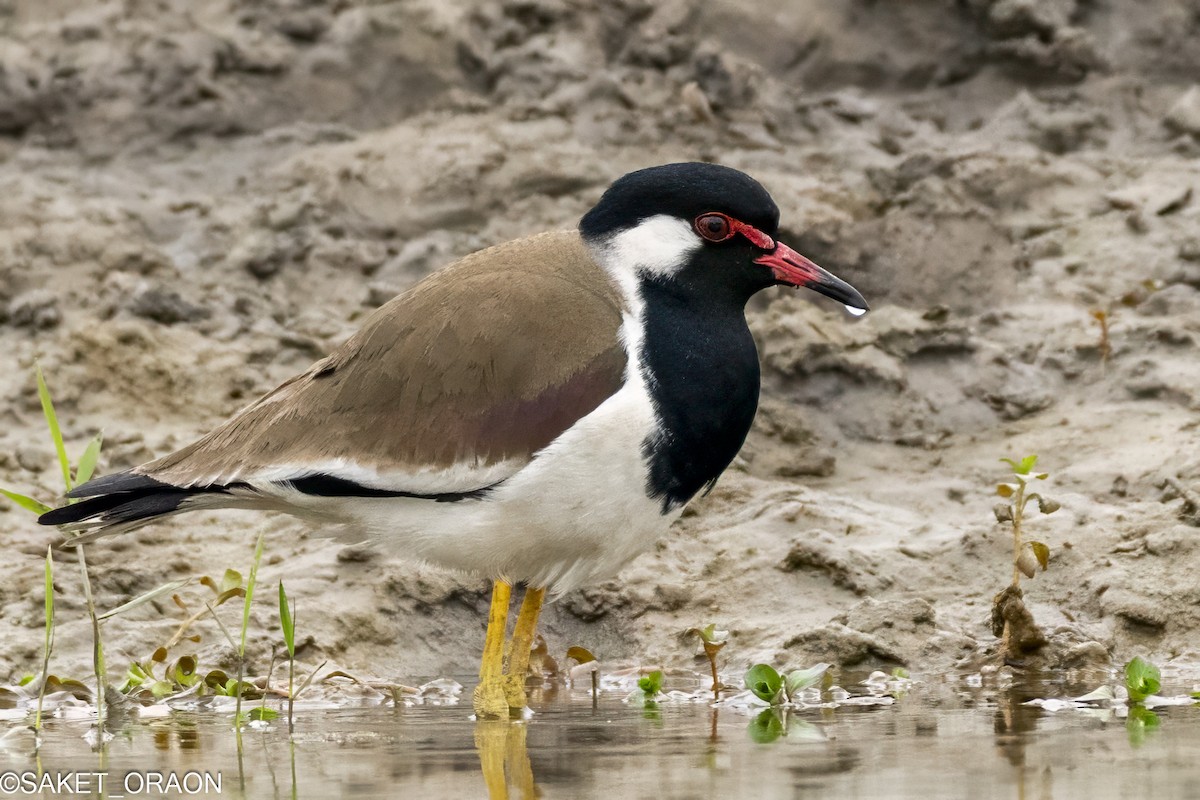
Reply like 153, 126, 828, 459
580, 163, 866, 309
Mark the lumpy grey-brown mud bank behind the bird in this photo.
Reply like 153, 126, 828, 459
0, 0, 1200, 678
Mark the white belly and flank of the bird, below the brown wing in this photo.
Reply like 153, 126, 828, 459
328, 380, 680, 594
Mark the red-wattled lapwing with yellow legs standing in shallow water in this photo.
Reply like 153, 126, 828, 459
38, 162, 868, 718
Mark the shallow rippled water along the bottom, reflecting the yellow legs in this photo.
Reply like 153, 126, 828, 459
9, 678, 1200, 799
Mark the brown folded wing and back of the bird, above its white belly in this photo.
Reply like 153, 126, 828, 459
136, 231, 626, 491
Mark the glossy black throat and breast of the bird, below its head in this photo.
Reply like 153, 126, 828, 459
641, 279, 758, 513
